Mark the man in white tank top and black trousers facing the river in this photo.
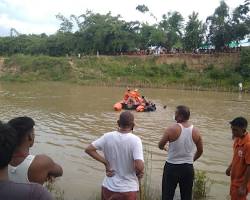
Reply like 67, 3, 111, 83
159, 106, 203, 200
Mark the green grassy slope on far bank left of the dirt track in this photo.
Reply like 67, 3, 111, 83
1, 55, 71, 82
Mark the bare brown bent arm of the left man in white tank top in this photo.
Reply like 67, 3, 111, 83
28, 155, 63, 184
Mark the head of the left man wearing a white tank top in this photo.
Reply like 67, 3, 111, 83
8, 117, 35, 147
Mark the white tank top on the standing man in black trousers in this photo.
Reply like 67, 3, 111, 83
167, 123, 196, 164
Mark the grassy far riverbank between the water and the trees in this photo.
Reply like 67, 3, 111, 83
0, 49, 250, 92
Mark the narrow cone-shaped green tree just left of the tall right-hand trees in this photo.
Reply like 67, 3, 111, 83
183, 12, 206, 51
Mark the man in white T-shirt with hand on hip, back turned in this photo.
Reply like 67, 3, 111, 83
85, 111, 144, 200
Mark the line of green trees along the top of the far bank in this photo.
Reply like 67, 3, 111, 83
0, 0, 250, 56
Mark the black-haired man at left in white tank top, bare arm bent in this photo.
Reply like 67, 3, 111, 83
8, 117, 63, 184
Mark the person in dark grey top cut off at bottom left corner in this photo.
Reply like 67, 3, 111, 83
0, 122, 52, 200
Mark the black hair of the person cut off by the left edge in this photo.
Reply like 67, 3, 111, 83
0, 121, 17, 169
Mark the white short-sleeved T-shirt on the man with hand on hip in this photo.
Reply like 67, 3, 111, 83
92, 131, 143, 192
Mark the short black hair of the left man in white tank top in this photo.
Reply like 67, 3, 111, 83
8, 116, 35, 145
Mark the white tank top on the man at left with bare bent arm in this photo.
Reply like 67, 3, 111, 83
8, 155, 35, 183
